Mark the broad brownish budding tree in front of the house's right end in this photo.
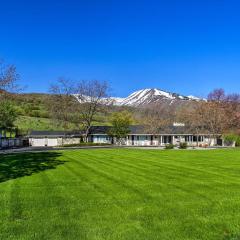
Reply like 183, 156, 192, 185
180, 89, 240, 146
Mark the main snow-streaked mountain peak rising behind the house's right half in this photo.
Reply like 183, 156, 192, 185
111, 88, 201, 106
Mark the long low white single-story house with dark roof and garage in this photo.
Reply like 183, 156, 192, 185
28, 125, 223, 147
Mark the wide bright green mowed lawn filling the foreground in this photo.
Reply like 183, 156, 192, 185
0, 149, 240, 240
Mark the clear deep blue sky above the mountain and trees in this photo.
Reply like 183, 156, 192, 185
0, 0, 240, 96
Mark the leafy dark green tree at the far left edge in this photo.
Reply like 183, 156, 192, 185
0, 100, 17, 135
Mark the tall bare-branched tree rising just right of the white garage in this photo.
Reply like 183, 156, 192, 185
75, 80, 109, 141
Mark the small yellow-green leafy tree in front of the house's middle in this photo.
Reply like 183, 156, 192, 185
109, 111, 133, 144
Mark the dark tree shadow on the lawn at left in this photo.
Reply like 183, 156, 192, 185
0, 152, 66, 183
